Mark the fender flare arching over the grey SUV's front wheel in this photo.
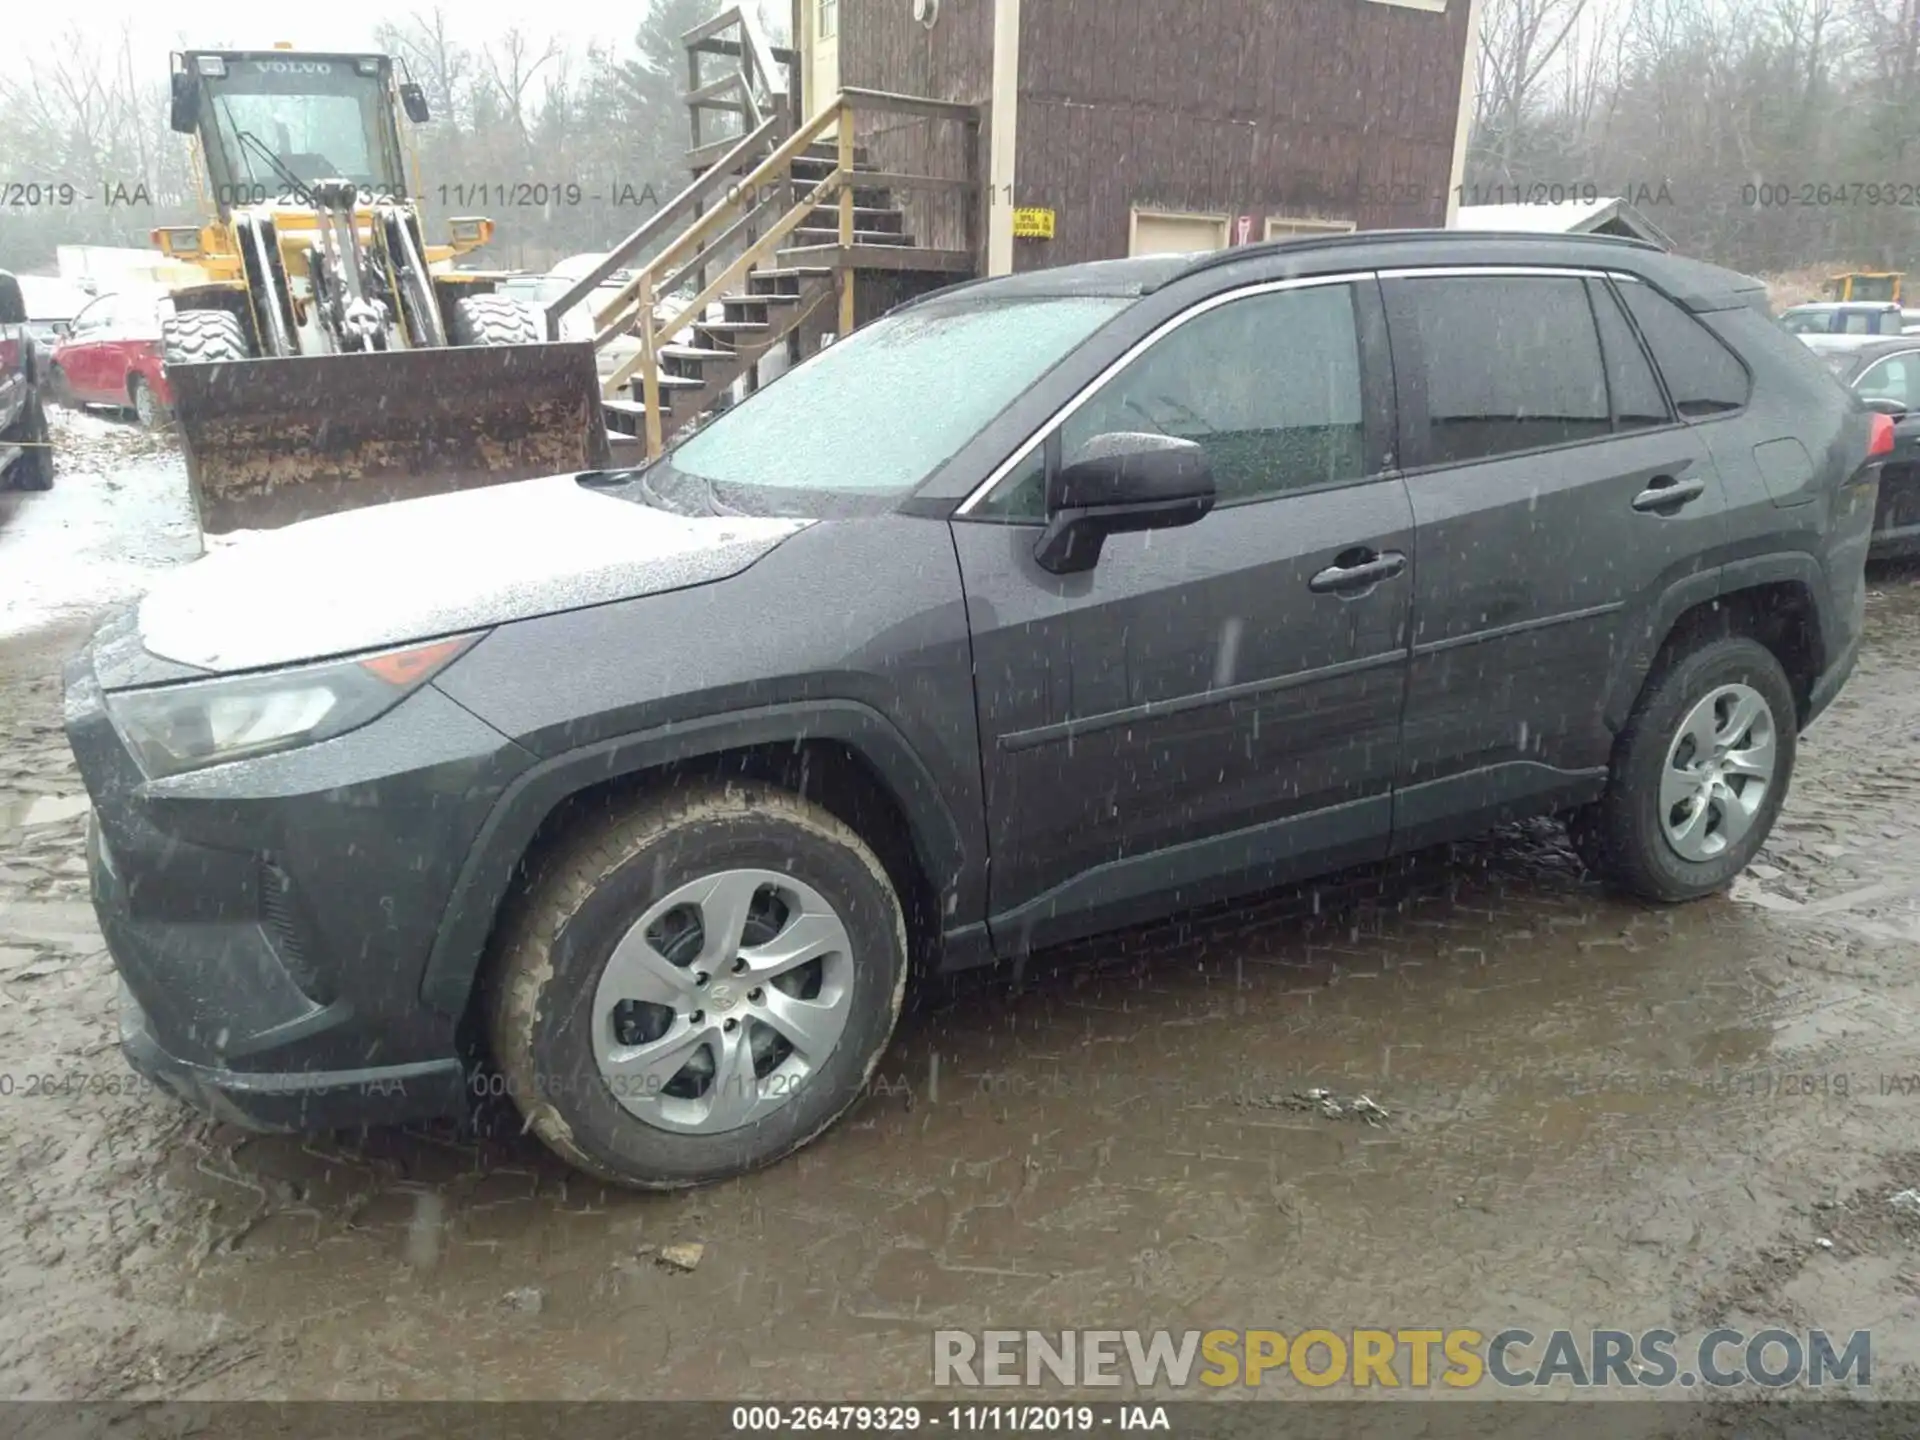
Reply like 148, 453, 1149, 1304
420, 701, 970, 1016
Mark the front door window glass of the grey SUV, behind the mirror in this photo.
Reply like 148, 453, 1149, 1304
981, 284, 1367, 520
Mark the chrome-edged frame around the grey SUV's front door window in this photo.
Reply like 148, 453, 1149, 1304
950, 271, 1400, 528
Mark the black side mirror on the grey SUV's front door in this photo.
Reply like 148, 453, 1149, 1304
1033, 432, 1213, 574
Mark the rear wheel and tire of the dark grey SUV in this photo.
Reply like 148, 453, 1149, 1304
1571, 636, 1799, 904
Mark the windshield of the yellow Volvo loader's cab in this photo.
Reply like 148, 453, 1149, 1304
202, 56, 407, 205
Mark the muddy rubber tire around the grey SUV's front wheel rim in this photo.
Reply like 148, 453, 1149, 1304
484, 783, 910, 1190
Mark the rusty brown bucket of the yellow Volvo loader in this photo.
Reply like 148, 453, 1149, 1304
167, 342, 609, 536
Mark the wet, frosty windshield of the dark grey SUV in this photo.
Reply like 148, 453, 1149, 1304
670, 296, 1133, 493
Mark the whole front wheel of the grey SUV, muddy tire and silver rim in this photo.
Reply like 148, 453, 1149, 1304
486, 785, 906, 1190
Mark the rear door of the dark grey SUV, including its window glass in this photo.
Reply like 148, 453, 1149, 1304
1386, 269, 1726, 849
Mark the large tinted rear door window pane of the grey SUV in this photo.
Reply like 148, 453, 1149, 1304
1404, 276, 1613, 465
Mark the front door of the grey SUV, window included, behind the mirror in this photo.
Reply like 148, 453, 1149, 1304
952, 278, 1413, 952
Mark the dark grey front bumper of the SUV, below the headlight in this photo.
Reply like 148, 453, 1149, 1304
65, 629, 530, 1129
